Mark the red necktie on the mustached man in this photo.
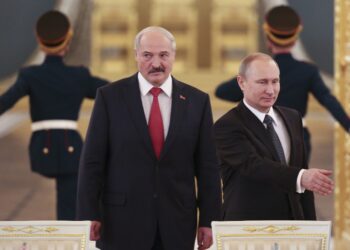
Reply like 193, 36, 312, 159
148, 88, 164, 159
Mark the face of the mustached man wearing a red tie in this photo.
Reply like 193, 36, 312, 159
136, 31, 175, 86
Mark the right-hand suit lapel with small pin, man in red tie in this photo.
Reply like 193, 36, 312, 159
160, 78, 187, 159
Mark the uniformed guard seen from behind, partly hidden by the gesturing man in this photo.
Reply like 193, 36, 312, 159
215, 5, 350, 161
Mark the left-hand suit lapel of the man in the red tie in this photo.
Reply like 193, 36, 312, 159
124, 74, 155, 157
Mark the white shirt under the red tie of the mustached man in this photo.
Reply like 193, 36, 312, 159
137, 72, 173, 139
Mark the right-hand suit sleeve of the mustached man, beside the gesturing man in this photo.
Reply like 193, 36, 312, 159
195, 96, 222, 227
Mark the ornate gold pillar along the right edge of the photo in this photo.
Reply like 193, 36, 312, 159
334, 0, 350, 250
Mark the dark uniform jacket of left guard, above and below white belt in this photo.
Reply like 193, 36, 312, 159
0, 56, 106, 176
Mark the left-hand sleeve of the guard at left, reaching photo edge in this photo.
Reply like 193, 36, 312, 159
0, 71, 29, 115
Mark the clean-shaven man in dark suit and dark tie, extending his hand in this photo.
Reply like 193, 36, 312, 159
215, 53, 333, 220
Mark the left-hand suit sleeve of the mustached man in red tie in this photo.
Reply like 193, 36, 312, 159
77, 90, 109, 221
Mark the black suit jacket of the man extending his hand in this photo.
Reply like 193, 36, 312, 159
215, 102, 316, 220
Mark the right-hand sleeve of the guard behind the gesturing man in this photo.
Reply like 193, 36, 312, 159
311, 69, 350, 132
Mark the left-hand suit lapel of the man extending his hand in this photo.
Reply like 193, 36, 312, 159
237, 102, 279, 161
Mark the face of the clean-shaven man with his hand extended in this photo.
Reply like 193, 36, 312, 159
237, 58, 280, 113
